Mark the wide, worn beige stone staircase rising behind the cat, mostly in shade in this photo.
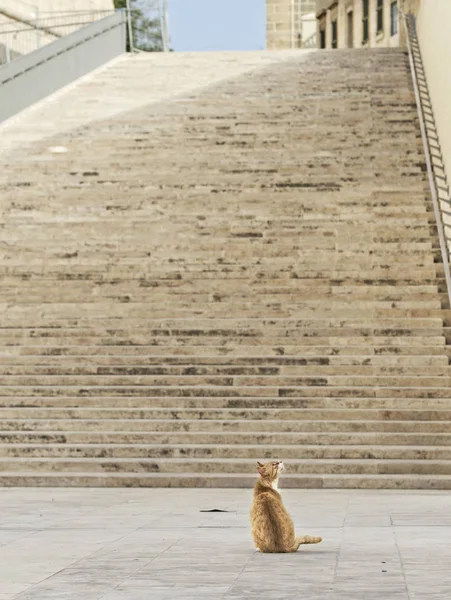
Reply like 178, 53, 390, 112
0, 49, 451, 489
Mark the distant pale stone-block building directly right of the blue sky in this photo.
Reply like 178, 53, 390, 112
266, 0, 316, 50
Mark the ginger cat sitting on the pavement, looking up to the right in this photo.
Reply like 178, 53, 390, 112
251, 460, 322, 552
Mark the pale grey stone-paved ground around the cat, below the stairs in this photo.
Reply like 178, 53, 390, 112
0, 489, 451, 600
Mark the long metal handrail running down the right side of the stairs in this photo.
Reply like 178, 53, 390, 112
401, 12, 451, 306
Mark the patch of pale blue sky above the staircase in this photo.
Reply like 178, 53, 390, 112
169, 0, 266, 51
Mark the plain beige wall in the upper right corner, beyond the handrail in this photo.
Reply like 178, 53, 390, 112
417, 0, 451, 193
